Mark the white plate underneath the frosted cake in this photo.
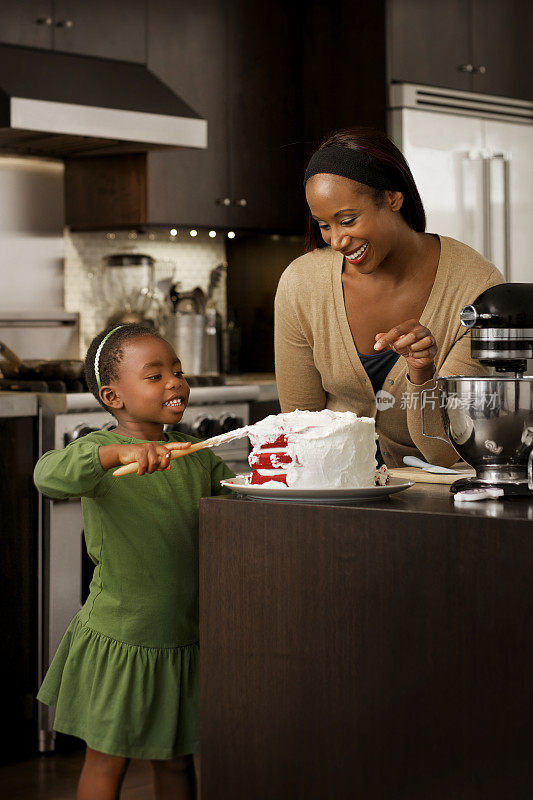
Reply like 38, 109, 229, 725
220, 475, 414, 503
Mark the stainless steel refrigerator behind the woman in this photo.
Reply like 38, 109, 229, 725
389, 83, 533, 282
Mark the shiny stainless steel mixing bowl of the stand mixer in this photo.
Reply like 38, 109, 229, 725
422, 375, 533, 490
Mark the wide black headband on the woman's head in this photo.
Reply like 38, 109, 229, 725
304, 147, 399, 191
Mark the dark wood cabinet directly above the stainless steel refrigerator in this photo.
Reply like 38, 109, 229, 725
387, 0, 533, 100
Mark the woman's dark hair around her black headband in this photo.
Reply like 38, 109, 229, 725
305, 128, 426, 252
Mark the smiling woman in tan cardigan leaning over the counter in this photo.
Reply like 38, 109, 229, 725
275, 128, 503, 467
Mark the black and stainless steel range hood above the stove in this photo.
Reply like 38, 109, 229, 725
0, 45, 207, 158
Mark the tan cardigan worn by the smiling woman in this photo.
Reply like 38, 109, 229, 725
275, 236, 504, 467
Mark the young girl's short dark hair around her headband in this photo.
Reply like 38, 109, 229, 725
85, 324, 161, 411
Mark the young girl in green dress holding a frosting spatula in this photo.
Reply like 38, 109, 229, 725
35, 325, 233, 800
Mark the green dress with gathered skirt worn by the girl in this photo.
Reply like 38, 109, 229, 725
34, 431, 233, 759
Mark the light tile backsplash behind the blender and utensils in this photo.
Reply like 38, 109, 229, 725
64, 230, 226, 357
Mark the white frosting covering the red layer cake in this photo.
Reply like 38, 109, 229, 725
248, 409, 376, 489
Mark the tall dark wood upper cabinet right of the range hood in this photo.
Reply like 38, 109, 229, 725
66, 0, 304, 232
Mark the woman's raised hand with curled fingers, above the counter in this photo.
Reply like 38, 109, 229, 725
374, 319, 437, 384
